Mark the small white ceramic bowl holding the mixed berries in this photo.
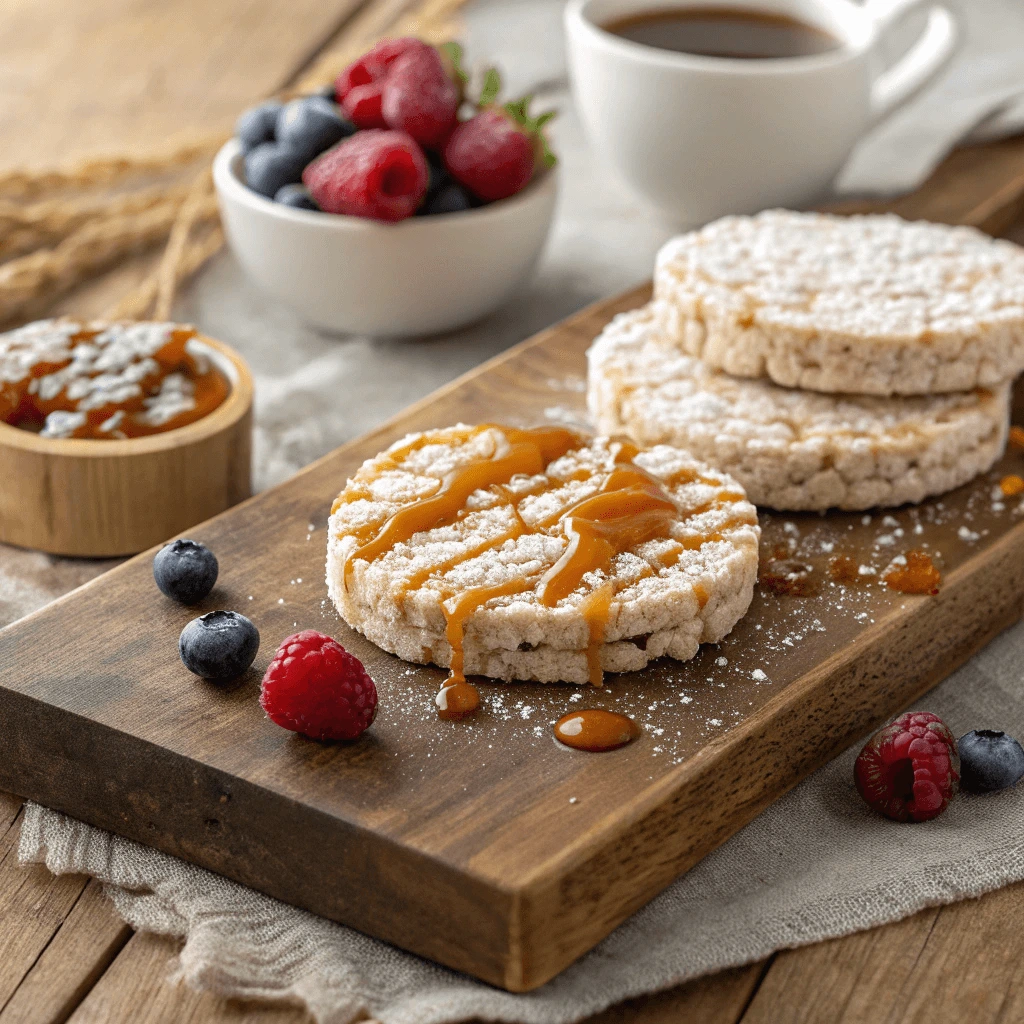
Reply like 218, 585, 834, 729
213, 139, 557, 337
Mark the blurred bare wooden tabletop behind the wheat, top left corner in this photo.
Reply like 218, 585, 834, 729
0, 0, 358, 170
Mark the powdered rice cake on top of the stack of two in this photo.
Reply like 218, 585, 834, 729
654, 210, 1024, 395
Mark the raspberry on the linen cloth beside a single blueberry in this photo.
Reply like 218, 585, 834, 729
853, 712, 961, 821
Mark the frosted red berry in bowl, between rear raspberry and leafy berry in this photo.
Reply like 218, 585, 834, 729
382, 44, 462, 147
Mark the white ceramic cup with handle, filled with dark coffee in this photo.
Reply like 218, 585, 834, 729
565, 0, 956, 225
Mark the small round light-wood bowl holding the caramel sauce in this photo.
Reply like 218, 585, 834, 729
0, 335, 253, 557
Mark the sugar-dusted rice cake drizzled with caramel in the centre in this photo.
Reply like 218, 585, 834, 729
327, 425, 760, 684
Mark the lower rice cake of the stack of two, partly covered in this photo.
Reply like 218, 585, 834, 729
587, 302, 1010, 511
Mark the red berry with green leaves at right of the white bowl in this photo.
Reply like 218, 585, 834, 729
444, 70, 555, 202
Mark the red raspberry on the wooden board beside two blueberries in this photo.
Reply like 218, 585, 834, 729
259, 630, 377, 739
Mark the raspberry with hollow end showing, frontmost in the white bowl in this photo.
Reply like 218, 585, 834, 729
302, 129, 429, 220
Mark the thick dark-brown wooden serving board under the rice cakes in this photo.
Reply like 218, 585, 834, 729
0, 289, 1024, 990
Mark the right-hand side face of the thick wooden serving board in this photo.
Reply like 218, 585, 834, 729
513, 523, 1024, 991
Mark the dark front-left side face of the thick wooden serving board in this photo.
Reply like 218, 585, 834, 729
0, 685, 517, 986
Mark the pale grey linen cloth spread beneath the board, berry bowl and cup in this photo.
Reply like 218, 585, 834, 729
6, 0, 1024, 1024
